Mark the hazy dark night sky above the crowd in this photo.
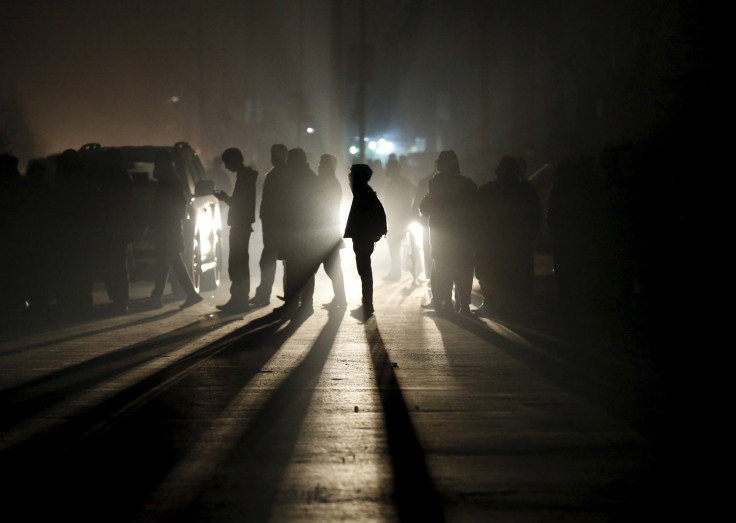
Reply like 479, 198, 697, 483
0, 0, 703, 175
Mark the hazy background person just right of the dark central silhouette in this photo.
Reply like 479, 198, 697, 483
383, 158, 416, 281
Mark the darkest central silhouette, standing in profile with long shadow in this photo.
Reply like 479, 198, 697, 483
343, 164, 387, 320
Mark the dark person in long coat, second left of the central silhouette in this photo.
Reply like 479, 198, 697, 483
274, 147, 322, 317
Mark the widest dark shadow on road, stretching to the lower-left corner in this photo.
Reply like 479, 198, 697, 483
0, 316, 316, 521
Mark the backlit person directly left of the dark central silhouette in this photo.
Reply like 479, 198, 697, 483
317, 154, 348, 309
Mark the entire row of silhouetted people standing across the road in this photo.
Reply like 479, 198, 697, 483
1, 144, 541, 319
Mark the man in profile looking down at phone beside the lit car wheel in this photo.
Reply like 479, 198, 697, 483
215, 147, 258, 314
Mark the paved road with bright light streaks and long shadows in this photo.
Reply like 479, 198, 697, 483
0, 256, 667, 522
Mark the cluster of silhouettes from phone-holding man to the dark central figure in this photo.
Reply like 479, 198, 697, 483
210, 144, 387, 319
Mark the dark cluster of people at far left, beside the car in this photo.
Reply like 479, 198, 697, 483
0, 148, 141, 321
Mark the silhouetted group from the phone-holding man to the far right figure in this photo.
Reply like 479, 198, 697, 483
207, 144, 543, 319
